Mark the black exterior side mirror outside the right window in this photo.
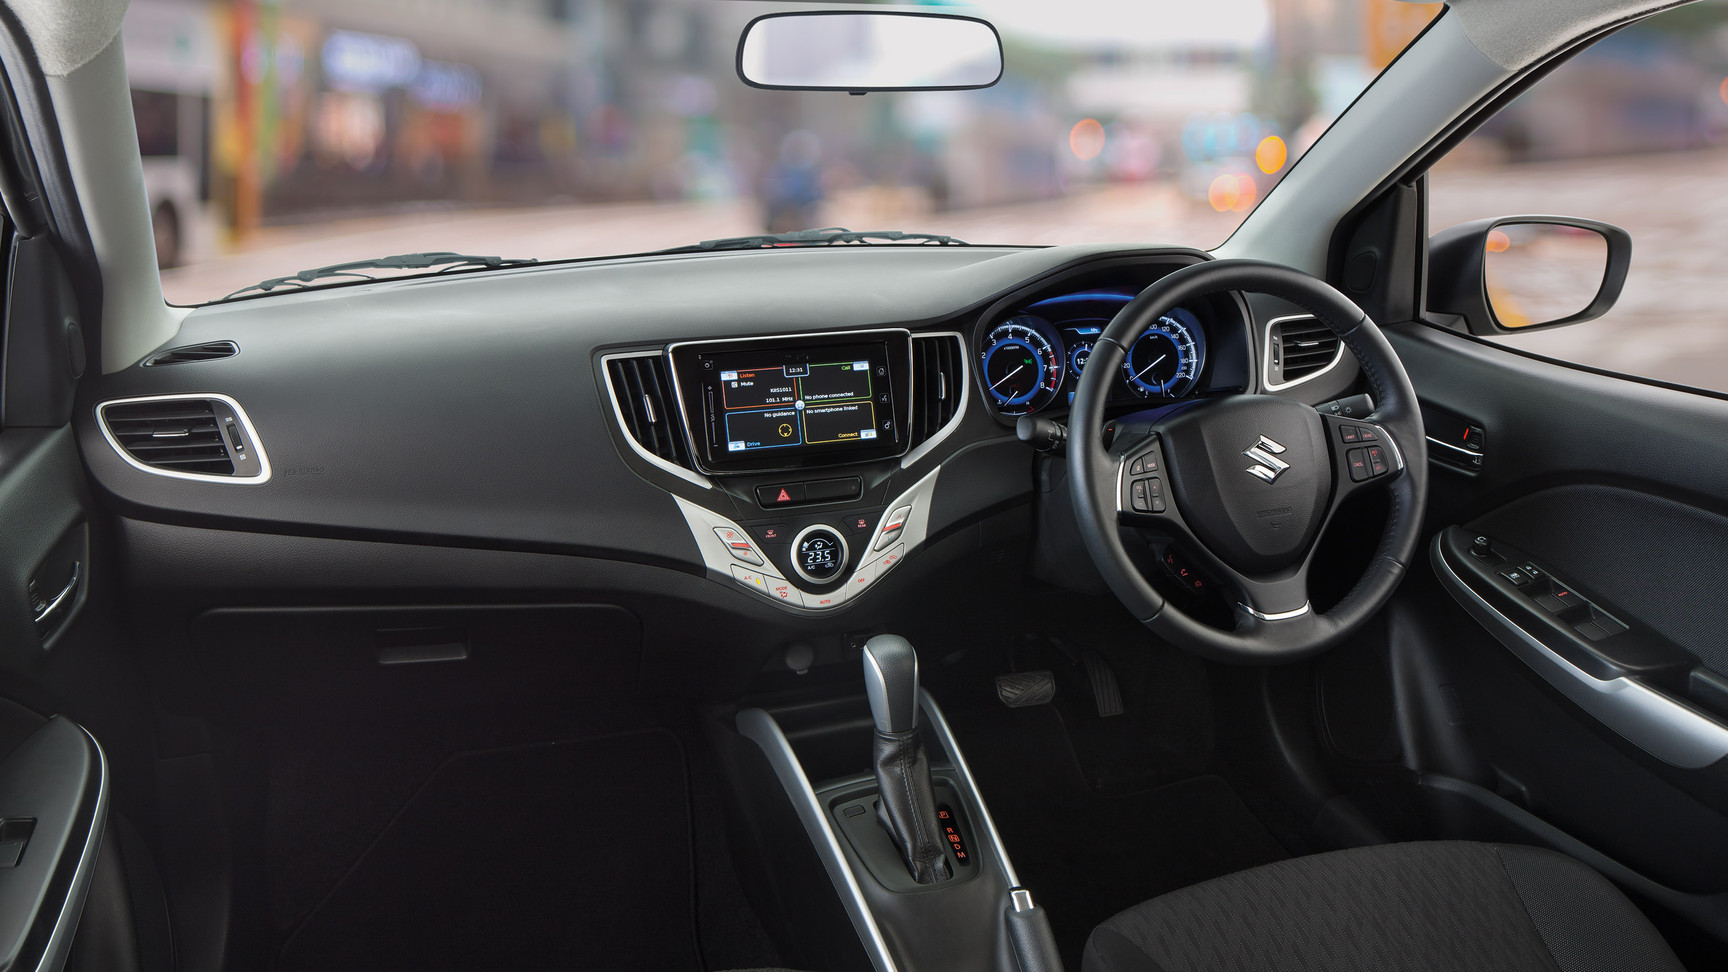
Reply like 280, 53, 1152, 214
1427, 216, 1631, 336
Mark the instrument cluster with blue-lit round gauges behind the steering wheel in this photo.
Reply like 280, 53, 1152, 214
978, 289, 1208, 417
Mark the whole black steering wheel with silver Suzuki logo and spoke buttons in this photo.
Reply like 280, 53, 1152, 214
1068, 259, 1427, 662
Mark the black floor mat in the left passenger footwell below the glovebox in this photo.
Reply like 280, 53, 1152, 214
280, 732, 700, 972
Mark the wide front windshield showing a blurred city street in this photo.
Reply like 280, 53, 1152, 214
123, 0, 1439, 303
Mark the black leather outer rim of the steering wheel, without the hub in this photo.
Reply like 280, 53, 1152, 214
1068, 259, 1427, 664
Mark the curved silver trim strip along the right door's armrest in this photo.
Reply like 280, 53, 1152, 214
1429, 536, 1728, 770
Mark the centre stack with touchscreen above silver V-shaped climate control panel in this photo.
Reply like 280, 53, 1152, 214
667, 329, 964, 611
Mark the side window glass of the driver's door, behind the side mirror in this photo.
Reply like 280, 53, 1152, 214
1429, 3, 1728, 393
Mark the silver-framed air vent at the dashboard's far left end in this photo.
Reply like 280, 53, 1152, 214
97, 394, 270, 484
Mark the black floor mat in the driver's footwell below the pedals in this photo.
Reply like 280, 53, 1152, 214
949, 706, 1289, 969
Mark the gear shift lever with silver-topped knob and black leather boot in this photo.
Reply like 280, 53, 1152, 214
864, 635, 950, 884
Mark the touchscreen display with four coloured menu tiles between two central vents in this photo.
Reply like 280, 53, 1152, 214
674, 330, 907, 469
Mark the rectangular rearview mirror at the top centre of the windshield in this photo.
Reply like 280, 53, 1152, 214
738, 10, 1002, 93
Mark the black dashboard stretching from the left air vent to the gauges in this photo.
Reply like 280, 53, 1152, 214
78, 246, 1355, 664
